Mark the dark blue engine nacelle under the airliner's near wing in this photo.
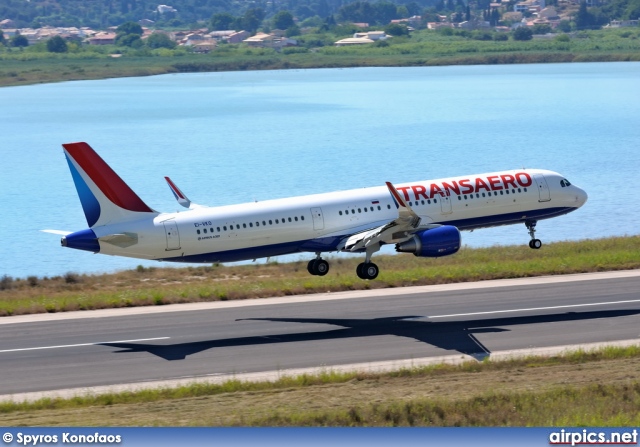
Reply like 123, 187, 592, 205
396, 225, 461, 258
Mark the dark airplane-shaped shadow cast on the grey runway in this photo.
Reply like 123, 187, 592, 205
101, 310, 640, 360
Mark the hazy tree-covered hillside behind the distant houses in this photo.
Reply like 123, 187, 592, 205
0, 0, 640, 28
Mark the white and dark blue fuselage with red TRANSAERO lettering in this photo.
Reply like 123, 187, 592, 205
93, 169, 587, 263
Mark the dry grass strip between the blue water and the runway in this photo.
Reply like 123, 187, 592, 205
0, 236, 640, 315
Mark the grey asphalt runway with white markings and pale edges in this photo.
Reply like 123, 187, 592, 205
0, 270, 640, 400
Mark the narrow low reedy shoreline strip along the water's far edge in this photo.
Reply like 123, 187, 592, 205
0, 51, 640, 88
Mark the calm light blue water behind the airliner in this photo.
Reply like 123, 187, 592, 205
0, 63, 640, 277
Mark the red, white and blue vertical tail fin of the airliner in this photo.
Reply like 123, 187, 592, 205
62, 143, 158, 228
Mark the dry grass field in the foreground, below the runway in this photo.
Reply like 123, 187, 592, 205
0, 346, 640, 426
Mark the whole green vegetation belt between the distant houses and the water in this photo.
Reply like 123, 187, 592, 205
0, 29, 640, 86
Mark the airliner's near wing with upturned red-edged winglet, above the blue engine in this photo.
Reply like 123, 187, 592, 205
342, 182, 440, 252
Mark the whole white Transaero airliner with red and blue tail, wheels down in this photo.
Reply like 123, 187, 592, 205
43, 142, 587, 280
